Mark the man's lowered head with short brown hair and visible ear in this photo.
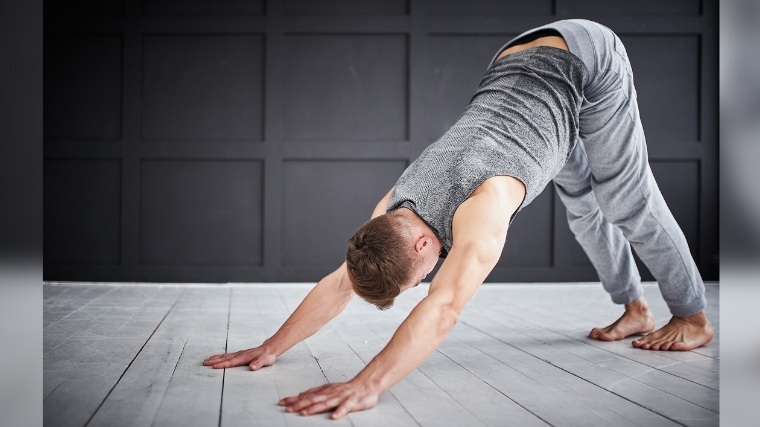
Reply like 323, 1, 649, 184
346, 209, 441, 310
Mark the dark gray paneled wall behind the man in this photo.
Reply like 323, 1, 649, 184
44, 0, 718, 282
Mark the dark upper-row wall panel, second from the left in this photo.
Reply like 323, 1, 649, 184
141, 34, 264, 140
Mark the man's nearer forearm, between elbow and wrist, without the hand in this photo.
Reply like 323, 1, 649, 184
354, 298, 459, 395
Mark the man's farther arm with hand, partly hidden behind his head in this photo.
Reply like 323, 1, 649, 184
203, 189, 393, 371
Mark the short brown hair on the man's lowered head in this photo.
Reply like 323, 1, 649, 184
346, 212, 414, 310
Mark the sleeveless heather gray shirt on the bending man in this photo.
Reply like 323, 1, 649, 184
387, 46, 588, 253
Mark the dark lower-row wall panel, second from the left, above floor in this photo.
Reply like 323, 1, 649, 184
140, 160, 263, 266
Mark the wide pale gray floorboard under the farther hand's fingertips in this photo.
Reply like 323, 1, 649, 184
91, 288, 236, 426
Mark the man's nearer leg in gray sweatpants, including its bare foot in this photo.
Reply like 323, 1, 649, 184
568, 20, 713, 350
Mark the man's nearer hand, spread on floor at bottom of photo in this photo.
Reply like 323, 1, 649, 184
277, 380, 378, 420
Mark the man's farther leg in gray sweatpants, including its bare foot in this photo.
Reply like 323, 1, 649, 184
554, 141, 655, 341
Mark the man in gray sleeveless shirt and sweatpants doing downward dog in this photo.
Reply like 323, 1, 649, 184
204, 20, 713, 419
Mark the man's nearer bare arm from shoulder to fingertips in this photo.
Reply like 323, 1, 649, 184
280, 177, 525, 419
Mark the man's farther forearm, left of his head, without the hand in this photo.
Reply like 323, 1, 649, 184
264, 264, 353, 356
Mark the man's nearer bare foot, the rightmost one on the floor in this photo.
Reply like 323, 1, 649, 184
632, 311, 714, 351
